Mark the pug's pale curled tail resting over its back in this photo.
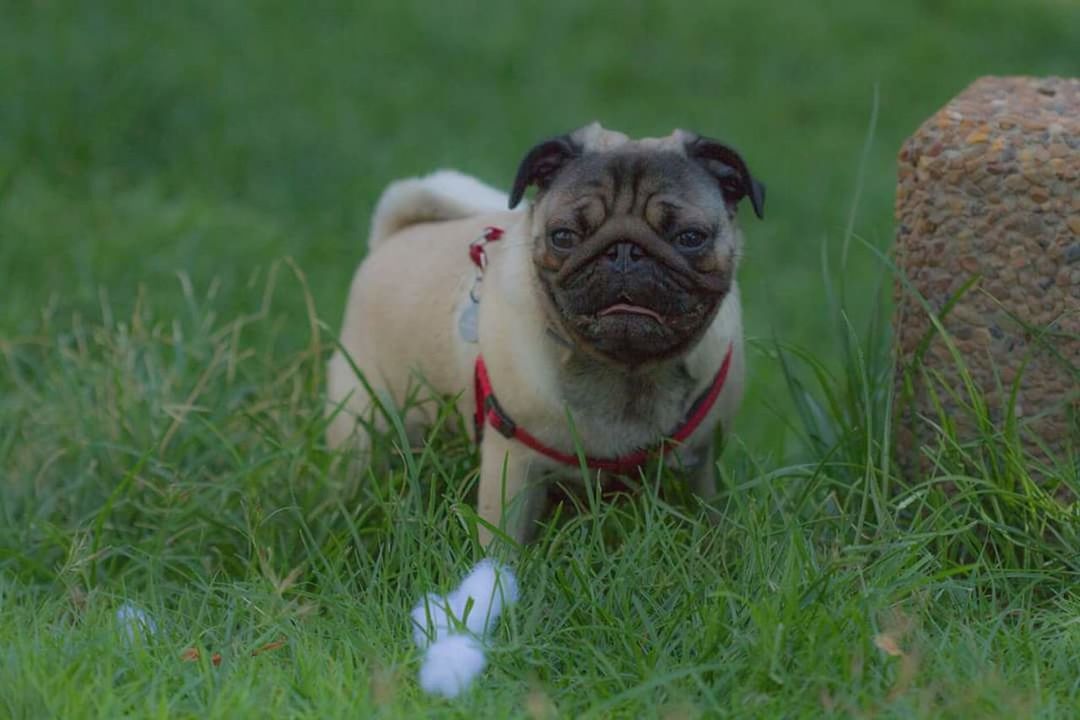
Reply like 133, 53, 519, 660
367, 169, 509, 253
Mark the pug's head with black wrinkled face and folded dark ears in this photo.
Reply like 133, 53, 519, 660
510, 123, 765, 367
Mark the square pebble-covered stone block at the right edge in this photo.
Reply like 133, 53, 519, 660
894, 78, 1080, 481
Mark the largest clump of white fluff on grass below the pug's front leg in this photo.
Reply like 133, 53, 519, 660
410, 559, 517, 697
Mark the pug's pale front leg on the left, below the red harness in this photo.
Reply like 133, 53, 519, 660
476, 427, 548, 547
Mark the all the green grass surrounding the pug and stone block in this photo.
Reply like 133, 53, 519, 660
0, 0, 1080, 718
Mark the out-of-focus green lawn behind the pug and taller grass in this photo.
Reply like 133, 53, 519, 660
0, 0, 1080, 451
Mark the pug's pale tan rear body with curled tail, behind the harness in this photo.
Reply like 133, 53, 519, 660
327, 169, 519, 454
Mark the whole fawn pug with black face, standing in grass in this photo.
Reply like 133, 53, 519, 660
327, 123, 765, 544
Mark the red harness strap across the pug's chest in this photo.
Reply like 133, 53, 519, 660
473, 343, 734, 473
